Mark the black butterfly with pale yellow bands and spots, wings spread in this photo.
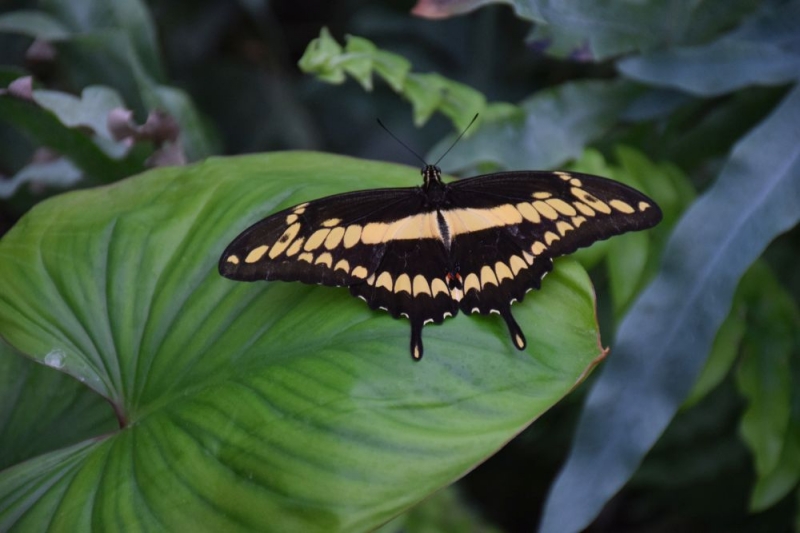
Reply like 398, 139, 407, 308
219, 164, 662, 360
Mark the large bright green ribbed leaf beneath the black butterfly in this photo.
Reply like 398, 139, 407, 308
0, 152, 603, 531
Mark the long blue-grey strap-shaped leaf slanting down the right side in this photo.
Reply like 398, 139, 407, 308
541, 78, 800, 533
